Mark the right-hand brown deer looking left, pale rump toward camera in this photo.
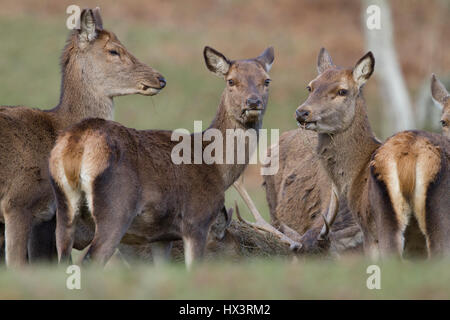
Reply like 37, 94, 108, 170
296, 49, 450, 256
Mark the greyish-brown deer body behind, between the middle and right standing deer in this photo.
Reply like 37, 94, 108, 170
263, 128, 362, 254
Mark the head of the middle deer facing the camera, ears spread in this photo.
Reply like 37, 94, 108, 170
203, 47, 274, 127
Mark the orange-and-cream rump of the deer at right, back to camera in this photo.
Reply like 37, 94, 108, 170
369, 131, 450, 256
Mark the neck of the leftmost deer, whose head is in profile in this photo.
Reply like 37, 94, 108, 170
50, 59, 114, 129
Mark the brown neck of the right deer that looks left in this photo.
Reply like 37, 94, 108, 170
317, 93, 380, 201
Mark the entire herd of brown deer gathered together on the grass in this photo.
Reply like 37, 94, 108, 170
0, 8, 450, 268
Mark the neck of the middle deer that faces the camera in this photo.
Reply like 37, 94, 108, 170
207, 92, 262, 190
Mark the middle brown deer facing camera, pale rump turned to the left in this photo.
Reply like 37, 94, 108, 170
50, 47, 274, 268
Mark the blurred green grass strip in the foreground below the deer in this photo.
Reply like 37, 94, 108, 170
0, 258, 450, 299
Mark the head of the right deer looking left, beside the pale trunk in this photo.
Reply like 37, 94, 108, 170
295, 48, 375, 134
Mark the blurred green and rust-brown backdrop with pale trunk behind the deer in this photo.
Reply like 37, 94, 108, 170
0, 0, 450, 220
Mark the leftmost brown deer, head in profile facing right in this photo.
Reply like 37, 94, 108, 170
0, 8, 166, 266
